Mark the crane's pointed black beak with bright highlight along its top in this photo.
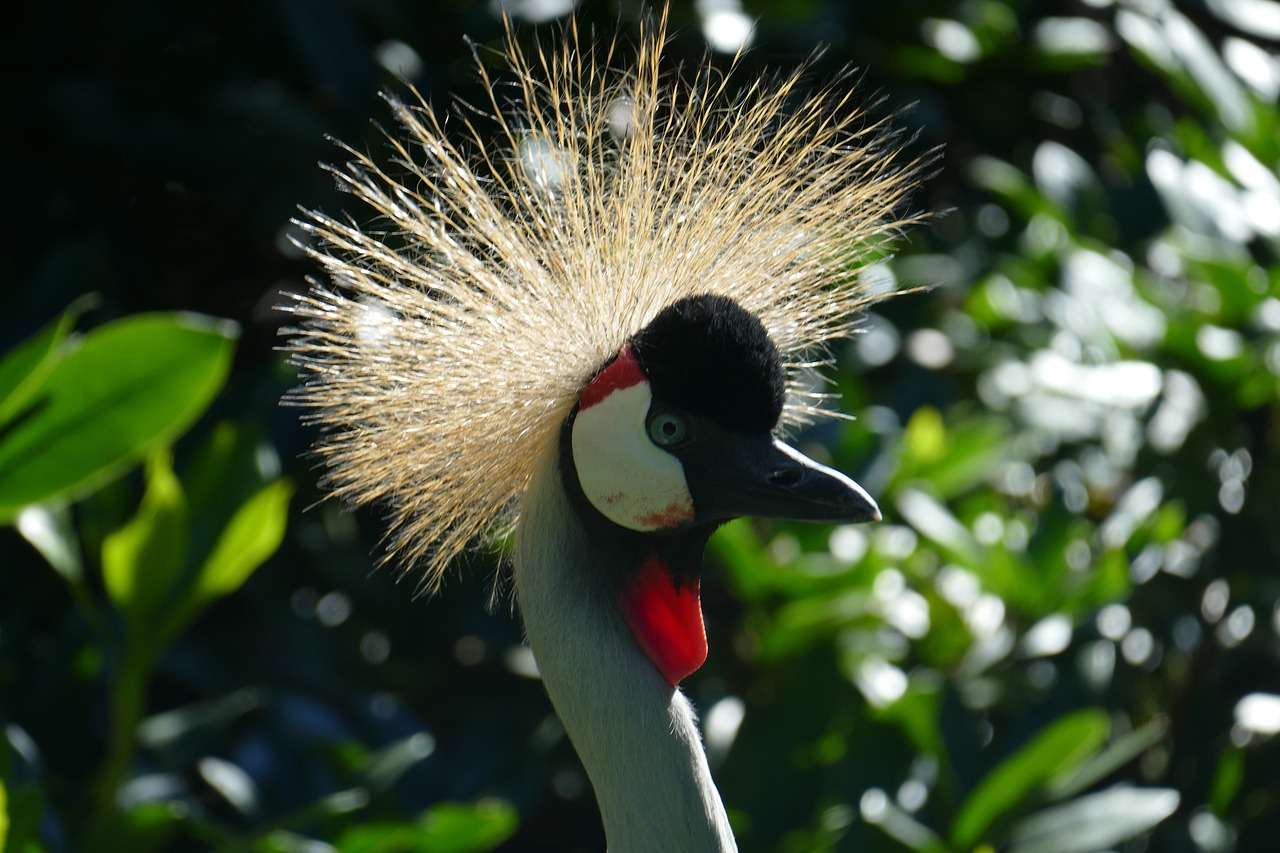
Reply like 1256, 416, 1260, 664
681, 433, 881, 523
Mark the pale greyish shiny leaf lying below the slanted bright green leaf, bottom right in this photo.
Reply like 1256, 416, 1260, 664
1009, 785, 1179, 853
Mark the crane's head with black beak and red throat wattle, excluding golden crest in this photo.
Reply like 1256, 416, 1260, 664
563, 295, 879, 686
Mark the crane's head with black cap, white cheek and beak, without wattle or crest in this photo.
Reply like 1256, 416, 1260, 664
566, 295, 879, 535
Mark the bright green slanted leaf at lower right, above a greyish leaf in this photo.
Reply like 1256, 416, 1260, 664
951, 708, 1111, 849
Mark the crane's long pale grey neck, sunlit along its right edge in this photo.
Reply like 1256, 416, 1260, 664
516, 452, 737, 853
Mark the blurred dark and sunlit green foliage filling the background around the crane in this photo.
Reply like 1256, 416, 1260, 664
0, 0, 1280, 853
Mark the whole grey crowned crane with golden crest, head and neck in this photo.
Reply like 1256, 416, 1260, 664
289, 8, 918, 853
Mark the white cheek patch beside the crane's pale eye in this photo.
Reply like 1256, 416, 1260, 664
571, 382, 694, 532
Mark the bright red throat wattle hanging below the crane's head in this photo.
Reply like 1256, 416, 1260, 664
621, 558, 707, 686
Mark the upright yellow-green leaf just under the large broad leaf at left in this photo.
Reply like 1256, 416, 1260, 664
102, 450, 187, 628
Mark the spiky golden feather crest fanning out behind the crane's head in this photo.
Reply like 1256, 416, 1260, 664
287, 8, 918, 592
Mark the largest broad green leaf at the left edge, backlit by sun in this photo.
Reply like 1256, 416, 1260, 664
0, 314, 238, 520
